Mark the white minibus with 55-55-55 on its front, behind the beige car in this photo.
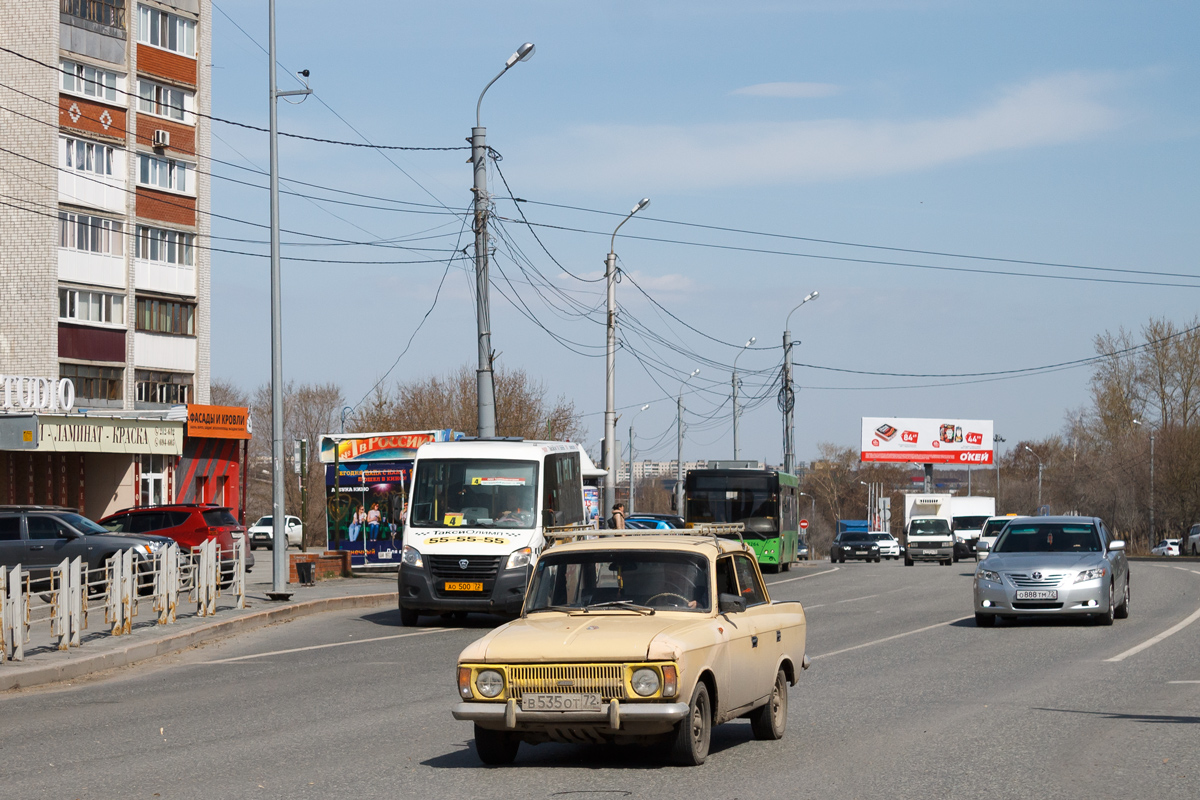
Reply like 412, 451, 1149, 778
397, 439, 592, 625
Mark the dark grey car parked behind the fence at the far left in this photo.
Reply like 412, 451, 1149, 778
0, 505, 170, 590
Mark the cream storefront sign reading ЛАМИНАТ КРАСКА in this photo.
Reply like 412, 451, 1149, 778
37, 416, 184, 456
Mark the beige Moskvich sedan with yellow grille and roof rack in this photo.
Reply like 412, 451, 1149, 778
454, 531, 808, 765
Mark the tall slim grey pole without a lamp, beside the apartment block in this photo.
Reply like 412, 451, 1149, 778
266, 0, 312, 600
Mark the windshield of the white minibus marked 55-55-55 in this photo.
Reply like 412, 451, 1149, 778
409, 458, 539, 528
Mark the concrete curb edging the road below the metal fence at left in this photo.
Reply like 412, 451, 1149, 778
0, 591, 400, 692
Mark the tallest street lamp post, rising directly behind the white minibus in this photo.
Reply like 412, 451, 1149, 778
470, 42, 534, 437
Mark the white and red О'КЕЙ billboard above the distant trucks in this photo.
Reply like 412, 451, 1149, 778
862, 416, 994, 465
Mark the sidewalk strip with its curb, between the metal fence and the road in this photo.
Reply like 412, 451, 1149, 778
0, 563, 398, 692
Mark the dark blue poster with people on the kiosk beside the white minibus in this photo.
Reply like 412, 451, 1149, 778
325, 461, 413, 565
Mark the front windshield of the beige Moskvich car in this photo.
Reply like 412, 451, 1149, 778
526, 551, 713, 613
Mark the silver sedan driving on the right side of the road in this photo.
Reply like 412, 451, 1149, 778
974, 517, 1129, 627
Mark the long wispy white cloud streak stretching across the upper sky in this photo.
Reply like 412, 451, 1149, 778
518, 73, 1123, 193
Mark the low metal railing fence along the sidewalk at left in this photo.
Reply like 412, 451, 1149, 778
0, 539, 246, 664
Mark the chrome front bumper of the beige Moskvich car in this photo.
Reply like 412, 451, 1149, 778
451, 700, 689, 735
